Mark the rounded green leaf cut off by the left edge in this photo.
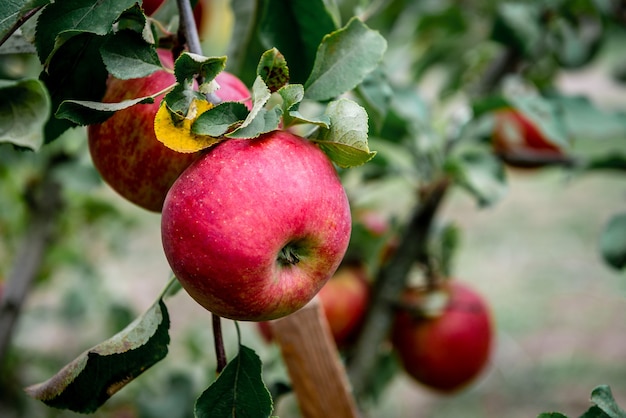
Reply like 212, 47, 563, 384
0, 79, 50, 151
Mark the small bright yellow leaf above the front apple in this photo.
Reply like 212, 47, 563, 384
154, 100, 220, 153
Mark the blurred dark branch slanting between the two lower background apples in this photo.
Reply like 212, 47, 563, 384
348, 179, 450, 399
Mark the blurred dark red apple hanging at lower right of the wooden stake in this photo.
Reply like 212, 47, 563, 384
392, 281, 493, 393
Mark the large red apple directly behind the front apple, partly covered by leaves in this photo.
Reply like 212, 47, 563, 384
87, 50, 250, 212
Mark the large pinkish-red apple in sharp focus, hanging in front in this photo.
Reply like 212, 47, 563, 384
161, 131, 351, 321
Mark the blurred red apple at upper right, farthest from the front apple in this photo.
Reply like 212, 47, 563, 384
492, 109, 563, 168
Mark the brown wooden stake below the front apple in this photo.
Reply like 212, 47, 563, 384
270, 298, 359, 418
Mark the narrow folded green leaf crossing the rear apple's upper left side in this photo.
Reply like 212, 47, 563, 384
54, 96, 154, 126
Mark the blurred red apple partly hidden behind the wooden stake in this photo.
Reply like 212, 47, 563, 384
258, 264, 370, 348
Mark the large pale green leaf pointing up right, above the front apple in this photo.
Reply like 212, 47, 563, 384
304, 18, 387, 101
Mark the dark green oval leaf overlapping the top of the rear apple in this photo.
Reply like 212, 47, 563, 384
100, 30, 162, 80
